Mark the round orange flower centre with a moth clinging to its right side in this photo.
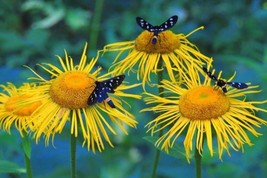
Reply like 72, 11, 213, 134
49, 71, 96, 109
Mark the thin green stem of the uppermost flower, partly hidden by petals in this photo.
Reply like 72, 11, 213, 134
151, 60, 164, 178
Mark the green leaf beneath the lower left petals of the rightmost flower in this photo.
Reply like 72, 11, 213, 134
143, 136, 185, 159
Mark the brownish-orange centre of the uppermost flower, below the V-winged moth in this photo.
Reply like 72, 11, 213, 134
135, 30, 181, 54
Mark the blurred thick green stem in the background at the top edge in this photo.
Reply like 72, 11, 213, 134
89, 0, 104, 50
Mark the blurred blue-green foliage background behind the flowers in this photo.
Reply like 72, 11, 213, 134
0, 0, 267, 178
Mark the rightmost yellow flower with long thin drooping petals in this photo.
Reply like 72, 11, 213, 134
143, 66, 267, 161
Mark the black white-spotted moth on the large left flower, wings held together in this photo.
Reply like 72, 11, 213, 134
87, 75, 125, 108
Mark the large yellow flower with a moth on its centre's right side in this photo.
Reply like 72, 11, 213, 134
25, 44, 140, 152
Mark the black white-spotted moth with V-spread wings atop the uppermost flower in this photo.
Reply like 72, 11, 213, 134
136, 15, 178, 44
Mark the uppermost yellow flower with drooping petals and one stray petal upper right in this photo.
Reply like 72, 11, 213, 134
102, 27, 212, 86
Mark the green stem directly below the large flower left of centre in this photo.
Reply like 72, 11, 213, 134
70, 134, 76, 178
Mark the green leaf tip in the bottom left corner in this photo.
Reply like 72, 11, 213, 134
0, 160, 26, 173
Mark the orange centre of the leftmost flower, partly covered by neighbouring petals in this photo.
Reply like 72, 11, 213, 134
5, 95, 42, 116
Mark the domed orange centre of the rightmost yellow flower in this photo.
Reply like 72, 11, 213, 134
179, 86, 230, 120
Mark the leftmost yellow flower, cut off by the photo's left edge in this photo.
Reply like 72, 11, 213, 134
0, 83, 42, 137
